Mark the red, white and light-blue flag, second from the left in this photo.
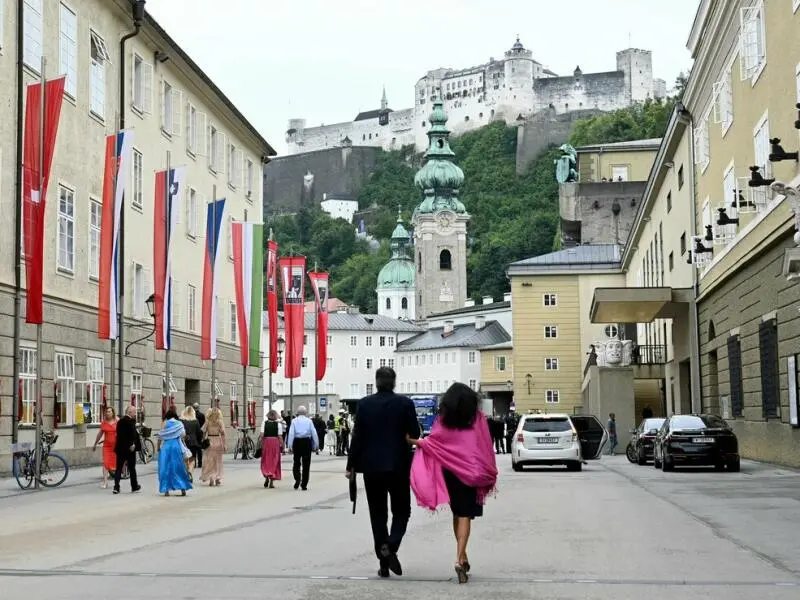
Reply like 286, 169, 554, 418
97, 130, 133, 340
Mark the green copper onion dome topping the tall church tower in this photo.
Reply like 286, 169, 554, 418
414, 98, 467, 214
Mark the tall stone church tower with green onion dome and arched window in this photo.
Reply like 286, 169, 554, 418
412, 97, 469, 318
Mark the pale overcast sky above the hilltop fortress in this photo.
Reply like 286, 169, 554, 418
147, 0, 697, 154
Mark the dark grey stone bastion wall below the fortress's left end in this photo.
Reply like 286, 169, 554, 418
264, 146, 382, 216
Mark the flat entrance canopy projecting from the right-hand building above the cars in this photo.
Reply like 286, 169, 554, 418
589, 287, 693, 323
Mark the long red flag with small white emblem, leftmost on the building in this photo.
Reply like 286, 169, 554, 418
22, 77, 66, 324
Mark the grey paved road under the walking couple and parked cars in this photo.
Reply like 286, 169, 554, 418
0, 456, 800, 600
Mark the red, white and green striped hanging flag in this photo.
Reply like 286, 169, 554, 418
231, 222, 264, 367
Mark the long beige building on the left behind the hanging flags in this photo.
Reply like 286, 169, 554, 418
0, 0, 274, 462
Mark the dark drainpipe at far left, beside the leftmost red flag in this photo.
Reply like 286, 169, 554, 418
11, 2, 25, 444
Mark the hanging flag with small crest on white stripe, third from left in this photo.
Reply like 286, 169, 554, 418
153, 167, 186, 350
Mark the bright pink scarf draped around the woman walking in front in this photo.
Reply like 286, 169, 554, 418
411, 411, 497, 510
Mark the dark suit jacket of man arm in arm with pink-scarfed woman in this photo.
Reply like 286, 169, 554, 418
347, 392, 420, 473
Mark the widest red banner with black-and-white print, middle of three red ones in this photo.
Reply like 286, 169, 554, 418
279, 256, 306, 379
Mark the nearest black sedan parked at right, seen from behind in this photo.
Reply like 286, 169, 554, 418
653, 415, 740, 471
